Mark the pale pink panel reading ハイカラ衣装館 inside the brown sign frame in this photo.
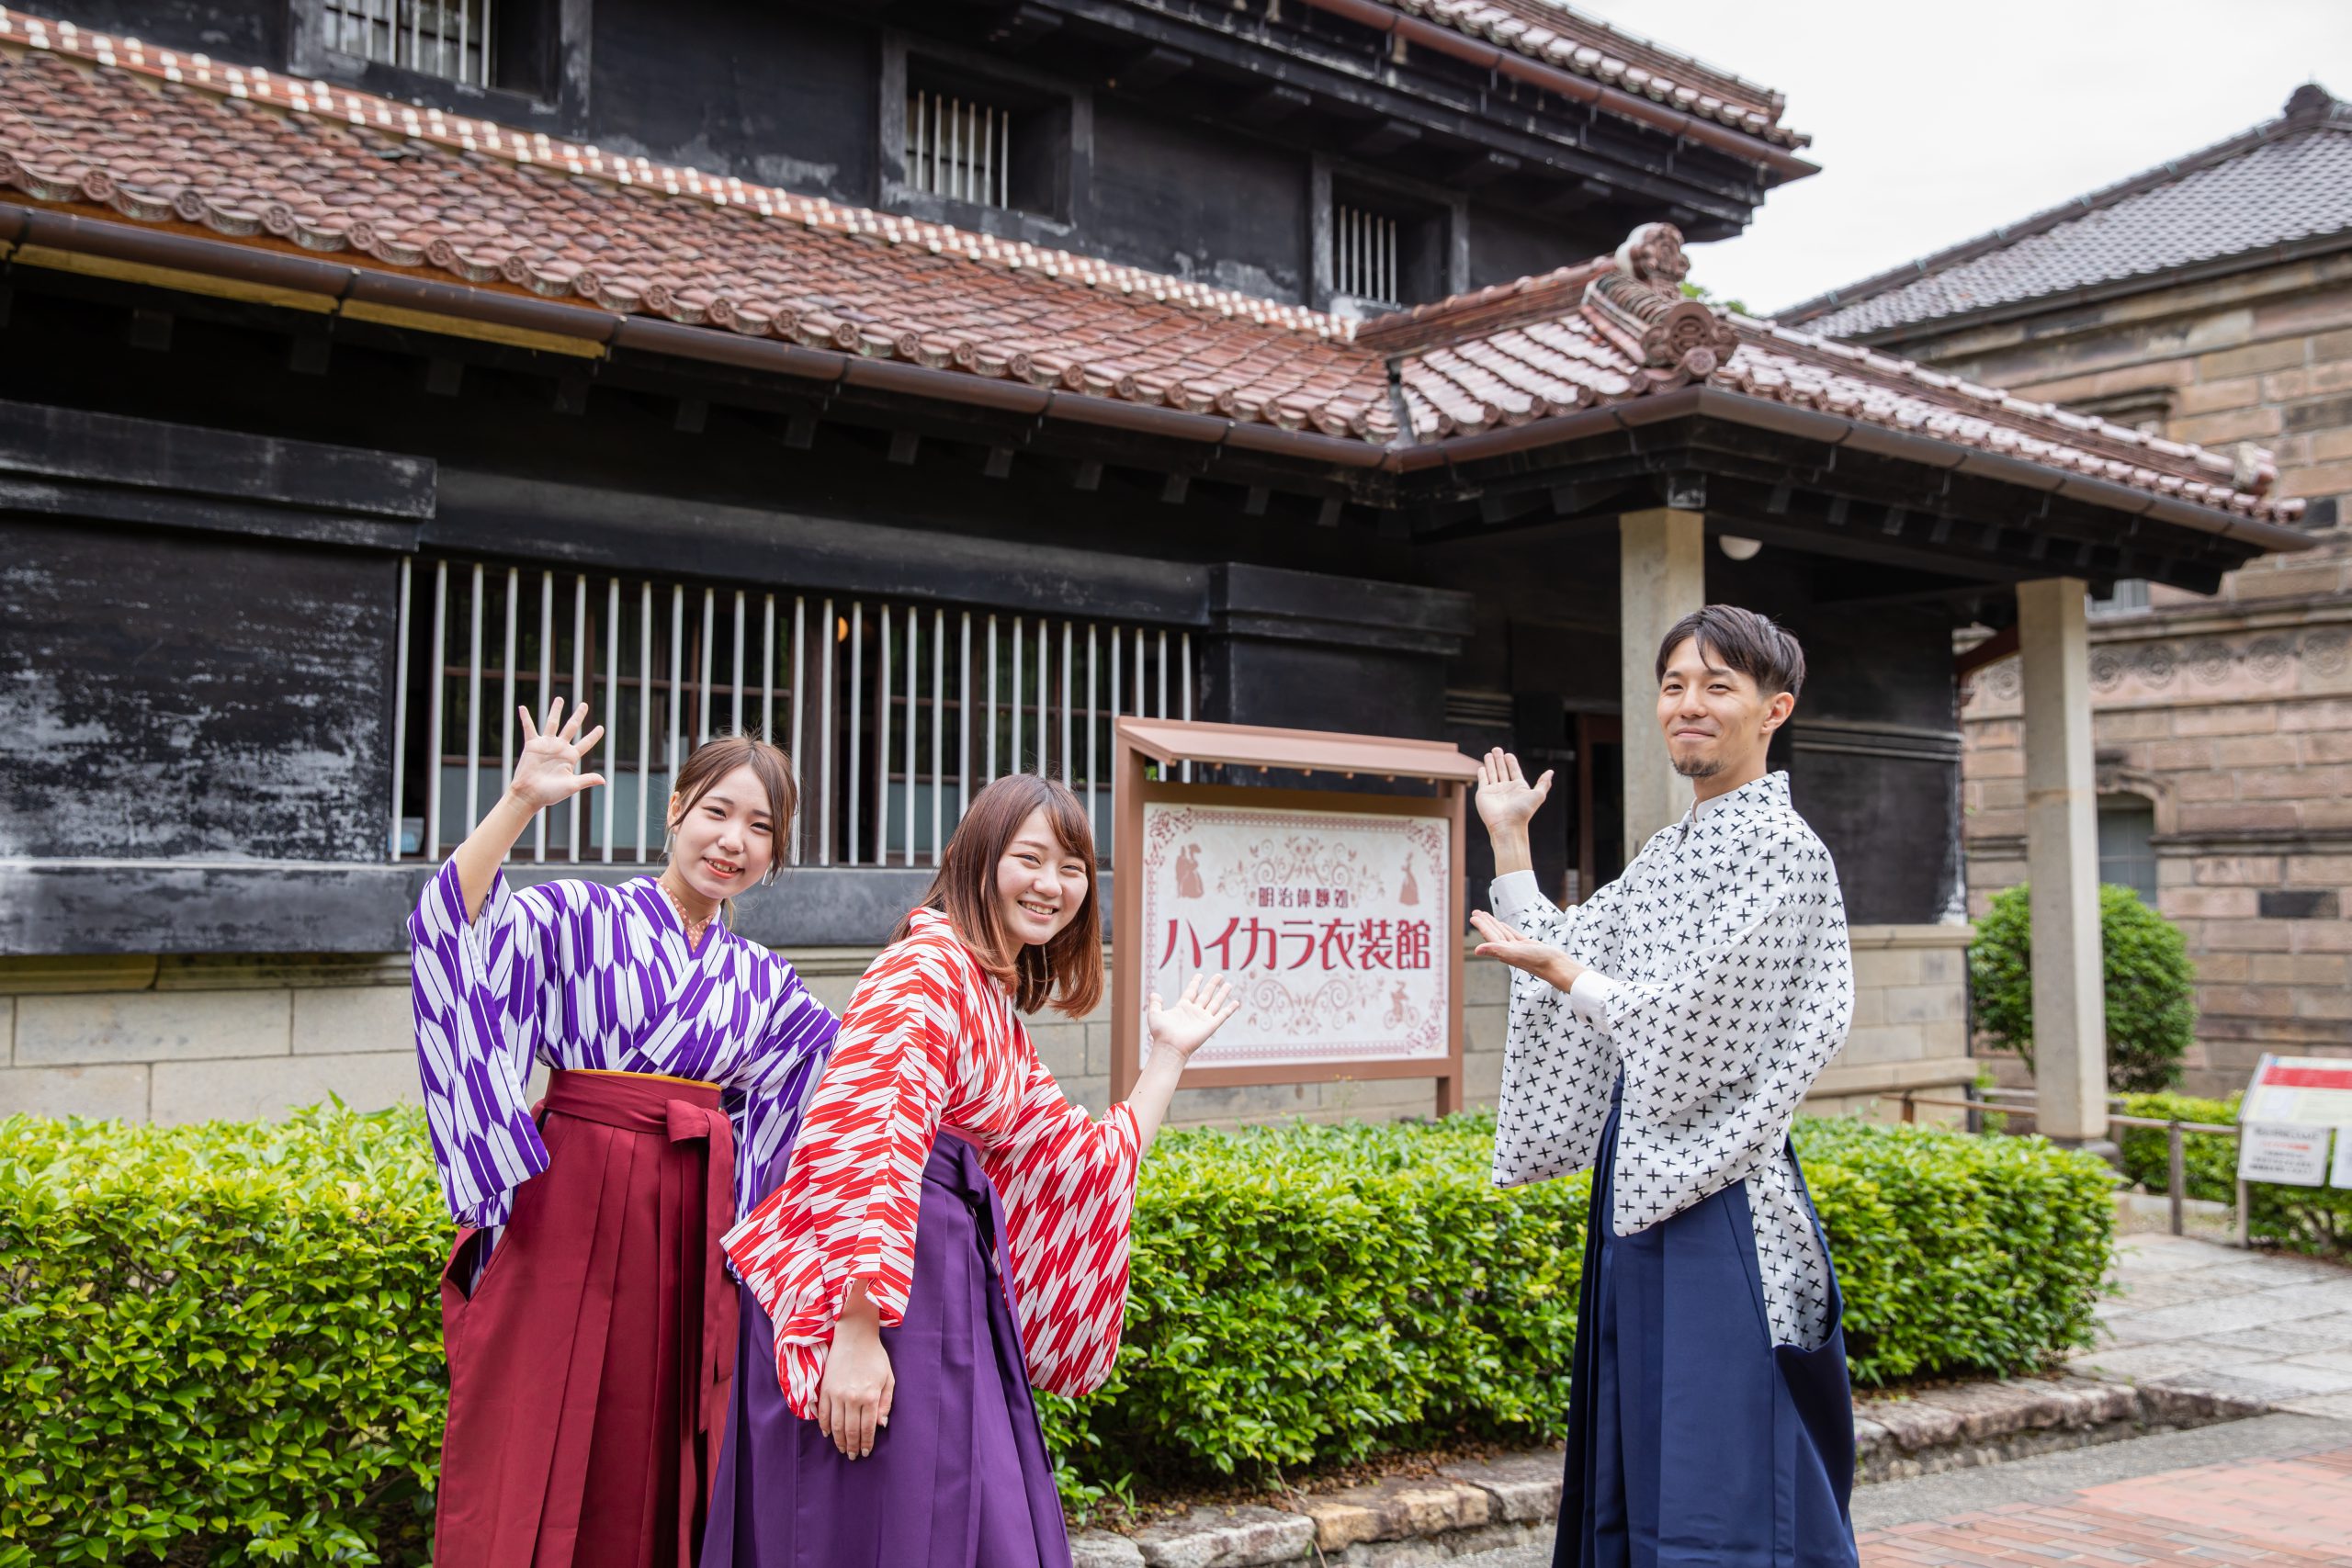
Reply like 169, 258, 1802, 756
1122, 802, 1453, 1067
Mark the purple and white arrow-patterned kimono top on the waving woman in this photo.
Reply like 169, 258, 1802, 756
409, 863, 840, 1227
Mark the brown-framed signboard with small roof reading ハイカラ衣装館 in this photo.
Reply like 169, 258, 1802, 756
1110, 719, 1477, 1114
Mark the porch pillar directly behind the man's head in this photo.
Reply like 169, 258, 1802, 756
1618, 508, 1708, 865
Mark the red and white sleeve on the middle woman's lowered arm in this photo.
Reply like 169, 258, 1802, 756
724, 933, 965, 1420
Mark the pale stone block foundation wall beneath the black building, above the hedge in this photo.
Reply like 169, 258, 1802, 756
0, 926, 1975, 1126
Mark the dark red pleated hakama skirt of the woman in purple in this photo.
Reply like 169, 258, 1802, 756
433, 1072, 736, 1568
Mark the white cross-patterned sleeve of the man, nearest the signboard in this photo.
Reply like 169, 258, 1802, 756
1494, 879, 1623, 1187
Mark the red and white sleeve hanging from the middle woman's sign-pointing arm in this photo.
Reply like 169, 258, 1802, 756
981, 1053, 1143, 1394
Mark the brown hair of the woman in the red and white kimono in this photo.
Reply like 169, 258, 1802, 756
891, 773, 1103, 1018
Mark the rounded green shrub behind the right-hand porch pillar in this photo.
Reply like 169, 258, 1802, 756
1969, 882, 2197, 1093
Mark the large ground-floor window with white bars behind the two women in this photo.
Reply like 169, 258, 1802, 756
388, 558, 1193, 865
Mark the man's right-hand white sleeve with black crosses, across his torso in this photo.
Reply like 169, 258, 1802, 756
1606, 820, 1853, 1236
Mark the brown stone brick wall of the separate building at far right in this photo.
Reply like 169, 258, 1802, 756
1886, 256, 2352, 1093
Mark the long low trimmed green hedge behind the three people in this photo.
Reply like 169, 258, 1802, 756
0, 1107, 2109, 1568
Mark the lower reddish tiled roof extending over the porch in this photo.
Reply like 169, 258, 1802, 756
0, 9, 2301, 520
